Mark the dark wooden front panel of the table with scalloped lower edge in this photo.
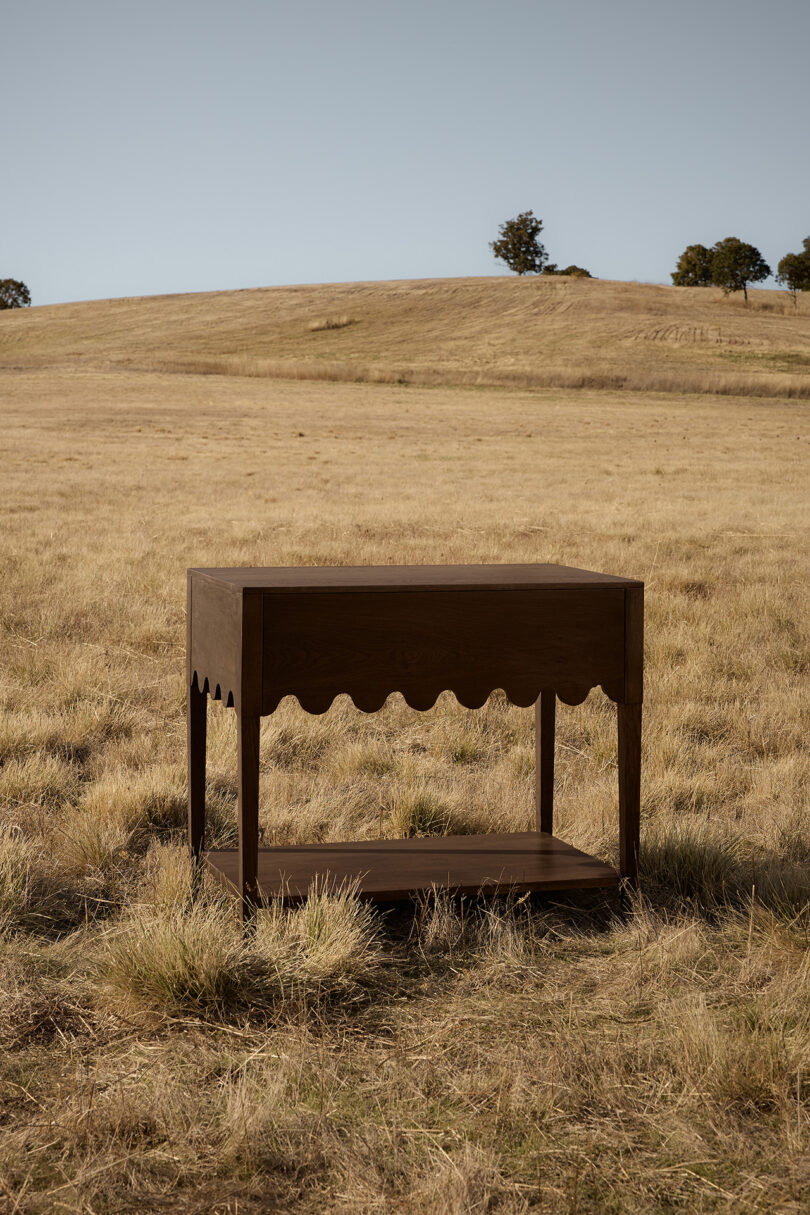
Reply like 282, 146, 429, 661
262, 586, 624, 713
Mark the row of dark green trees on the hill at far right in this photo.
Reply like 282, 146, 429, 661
672, 236, 810, 304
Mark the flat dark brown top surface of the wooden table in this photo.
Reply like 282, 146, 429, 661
188, 564, 644, 592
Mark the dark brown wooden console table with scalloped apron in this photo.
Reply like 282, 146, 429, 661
188, 565, 644, 917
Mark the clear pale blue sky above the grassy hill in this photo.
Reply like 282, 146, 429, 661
6, 0, 810, 304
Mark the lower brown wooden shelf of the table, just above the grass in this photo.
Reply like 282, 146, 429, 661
205, 831, 619, 903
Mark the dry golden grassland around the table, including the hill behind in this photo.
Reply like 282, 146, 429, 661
0, 279, 810, 1215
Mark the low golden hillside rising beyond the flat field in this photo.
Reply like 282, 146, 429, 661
0, 277, 810, 397
